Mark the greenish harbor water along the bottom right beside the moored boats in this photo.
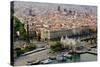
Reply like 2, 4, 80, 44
48, 53, 97, 64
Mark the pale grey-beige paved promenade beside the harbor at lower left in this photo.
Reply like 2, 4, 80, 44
14, 49, 49, 66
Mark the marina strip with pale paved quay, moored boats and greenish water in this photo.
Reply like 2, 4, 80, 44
15, 45, 97, 65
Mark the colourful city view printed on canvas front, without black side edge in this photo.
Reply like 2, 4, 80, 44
11, 1, 97, 66
